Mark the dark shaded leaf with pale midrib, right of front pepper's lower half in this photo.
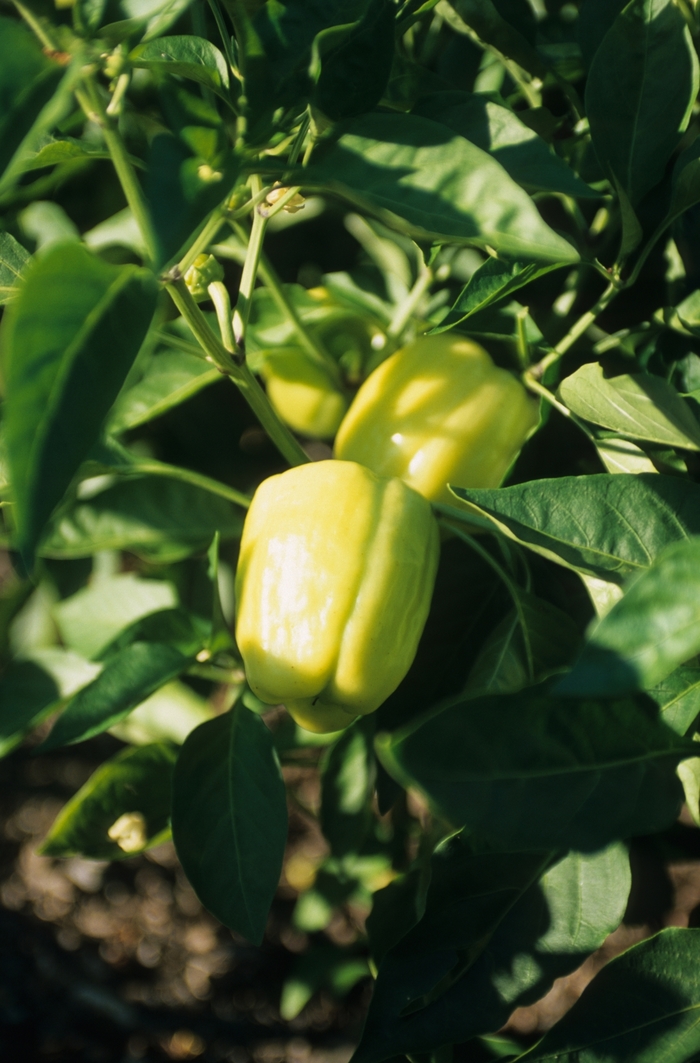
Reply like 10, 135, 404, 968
464, 591, 581, 697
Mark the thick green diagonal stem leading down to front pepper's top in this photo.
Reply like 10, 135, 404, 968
166, 280, 310, 466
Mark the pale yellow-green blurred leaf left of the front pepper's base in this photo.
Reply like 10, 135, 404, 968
109, 680, 212, 745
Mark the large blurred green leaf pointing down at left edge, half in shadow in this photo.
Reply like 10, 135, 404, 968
3, 243, 158, 567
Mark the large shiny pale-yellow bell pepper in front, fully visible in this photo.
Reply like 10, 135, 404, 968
236, 460, 439, 731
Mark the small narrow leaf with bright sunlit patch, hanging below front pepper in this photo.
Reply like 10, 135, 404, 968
320, 716, 376, 857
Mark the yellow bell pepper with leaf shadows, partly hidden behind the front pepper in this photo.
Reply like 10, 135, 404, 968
336, 334, 539, 505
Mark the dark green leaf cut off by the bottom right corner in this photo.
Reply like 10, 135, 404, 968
518, 927, 700, 1063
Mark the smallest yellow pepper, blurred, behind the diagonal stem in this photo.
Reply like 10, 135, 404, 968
262, 347, 347, 439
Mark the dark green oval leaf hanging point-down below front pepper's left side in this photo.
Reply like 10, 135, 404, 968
172, 702, 287, 945
